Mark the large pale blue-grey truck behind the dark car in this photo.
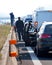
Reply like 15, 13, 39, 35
33, 10, 52, 28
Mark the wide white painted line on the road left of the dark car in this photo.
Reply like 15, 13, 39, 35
26, 47, 42, 65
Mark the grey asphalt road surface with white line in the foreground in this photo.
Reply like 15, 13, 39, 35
16, 42, 52, 65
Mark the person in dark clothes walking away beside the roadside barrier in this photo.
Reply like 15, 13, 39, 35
16, 17, 24, 40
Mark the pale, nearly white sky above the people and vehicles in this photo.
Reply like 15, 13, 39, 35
0, 0, 52, 17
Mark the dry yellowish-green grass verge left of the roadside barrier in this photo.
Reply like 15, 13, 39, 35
0, 25, 11, 51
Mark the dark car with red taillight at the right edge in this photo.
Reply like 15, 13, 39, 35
35, 22, 52, 56
